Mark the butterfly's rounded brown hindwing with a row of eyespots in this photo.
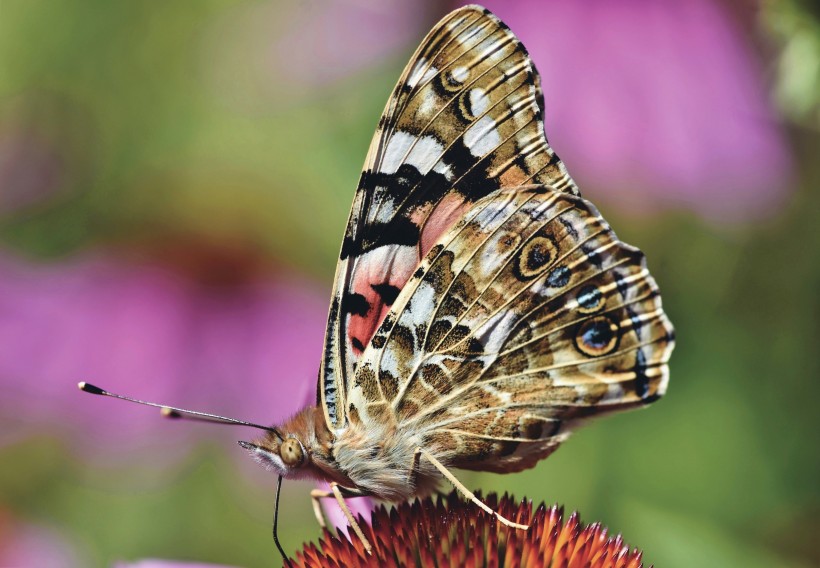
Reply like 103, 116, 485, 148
348, 186, 673, 471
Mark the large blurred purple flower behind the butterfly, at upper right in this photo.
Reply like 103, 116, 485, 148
474, 0, 790, 221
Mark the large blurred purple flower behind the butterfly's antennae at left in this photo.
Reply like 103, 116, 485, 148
0, 251, 327, 455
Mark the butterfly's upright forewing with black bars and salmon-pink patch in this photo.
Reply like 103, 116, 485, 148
318, 6, 577, 428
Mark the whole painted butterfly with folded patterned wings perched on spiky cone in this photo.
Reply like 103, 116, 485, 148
81, 0, 674, 551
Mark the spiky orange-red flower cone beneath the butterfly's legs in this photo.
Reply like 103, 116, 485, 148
294, 492, 643, 568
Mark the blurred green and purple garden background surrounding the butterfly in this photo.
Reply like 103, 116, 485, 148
0, 0, 820, 567
